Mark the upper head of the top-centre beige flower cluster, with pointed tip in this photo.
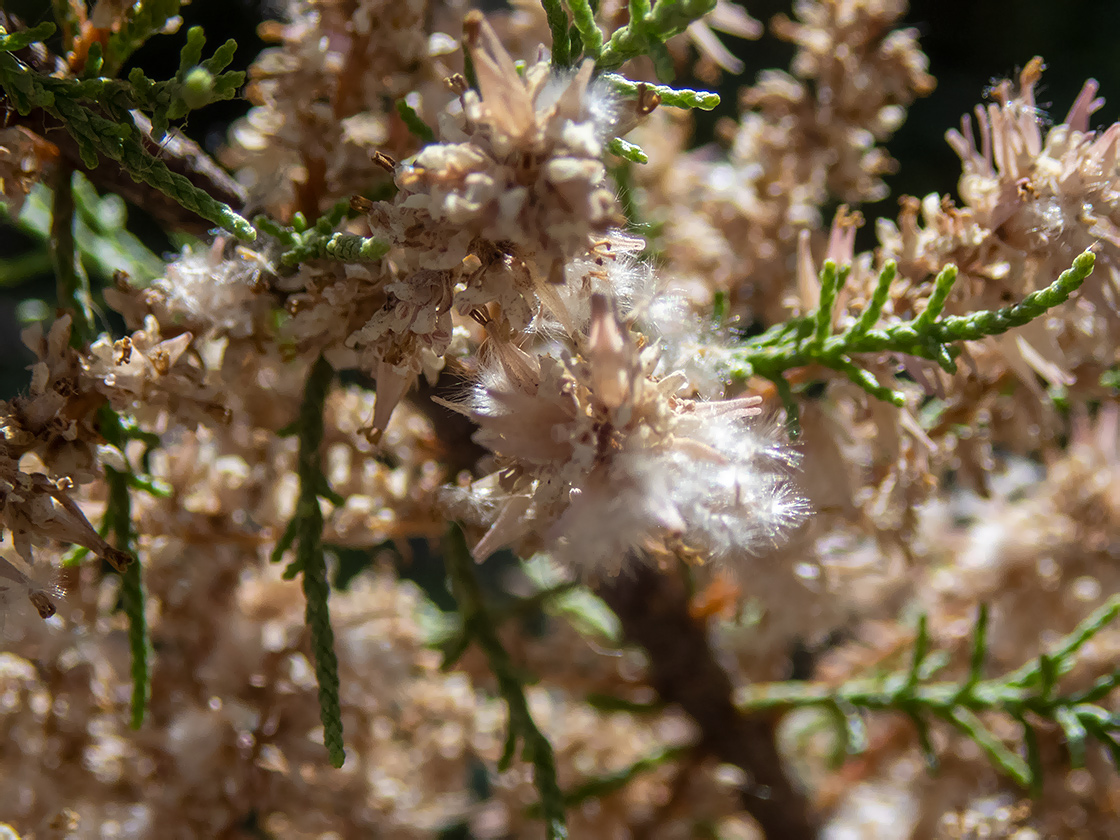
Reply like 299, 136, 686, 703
396, 17, 622, 282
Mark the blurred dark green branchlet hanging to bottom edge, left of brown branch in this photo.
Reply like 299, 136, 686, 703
444, 525, 568, 840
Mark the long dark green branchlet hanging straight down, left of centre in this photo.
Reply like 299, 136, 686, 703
272, 356, 346, 767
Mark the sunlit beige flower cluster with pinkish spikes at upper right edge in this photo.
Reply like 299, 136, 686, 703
878, 58, 1120, 321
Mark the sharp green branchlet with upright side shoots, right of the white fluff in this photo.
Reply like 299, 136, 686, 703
728, 251, 1095, 420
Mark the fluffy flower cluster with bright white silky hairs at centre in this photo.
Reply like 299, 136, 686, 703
439, 295, 804, 573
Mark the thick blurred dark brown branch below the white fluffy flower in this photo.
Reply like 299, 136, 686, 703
598, 561, 818, 840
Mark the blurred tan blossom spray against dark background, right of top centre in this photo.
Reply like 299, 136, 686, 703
634, 0, 940, 325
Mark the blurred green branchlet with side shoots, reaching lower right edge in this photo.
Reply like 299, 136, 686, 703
737, 596, 1120, 793
